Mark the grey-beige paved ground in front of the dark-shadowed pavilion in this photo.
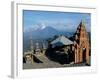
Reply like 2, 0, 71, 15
23, 55, 86, 69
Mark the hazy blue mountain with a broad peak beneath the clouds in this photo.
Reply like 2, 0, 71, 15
24, 26, 72, 39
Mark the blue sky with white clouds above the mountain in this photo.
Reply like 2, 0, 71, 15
23, 10, 91, 32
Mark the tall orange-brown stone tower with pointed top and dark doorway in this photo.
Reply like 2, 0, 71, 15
74, 21, 90, 64
